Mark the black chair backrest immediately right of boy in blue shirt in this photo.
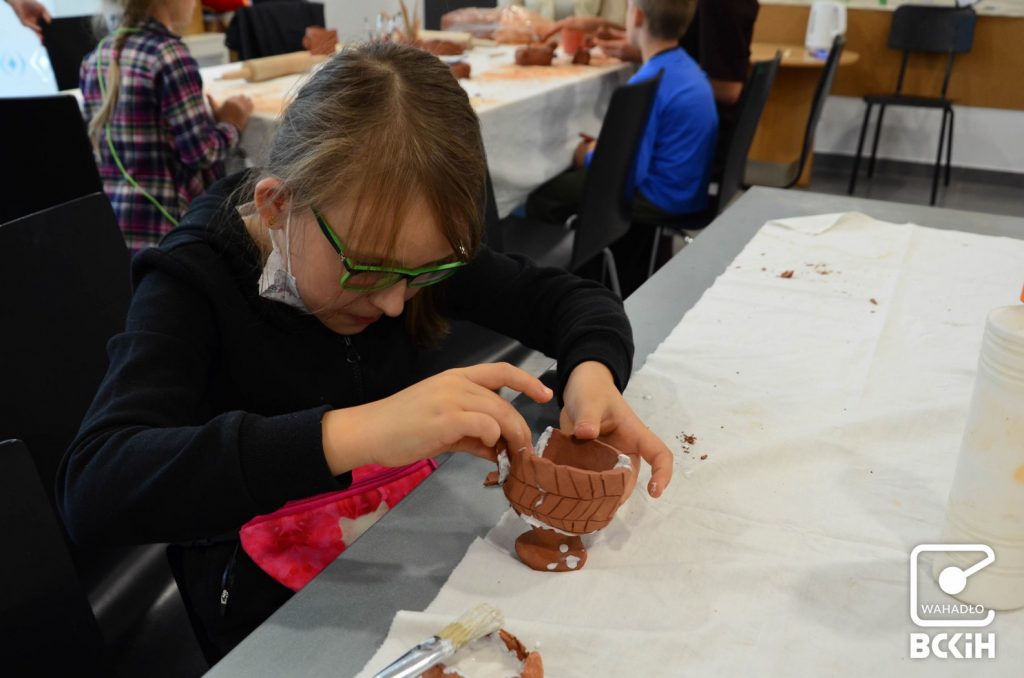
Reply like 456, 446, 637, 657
716, 52, 782, 212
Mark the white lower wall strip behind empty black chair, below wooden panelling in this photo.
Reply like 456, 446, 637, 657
814, 96, 1024, 173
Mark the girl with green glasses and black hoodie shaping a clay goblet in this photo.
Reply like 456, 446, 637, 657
57, 43, 672, 659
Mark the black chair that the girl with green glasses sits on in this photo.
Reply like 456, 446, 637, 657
0, 194, 206, 675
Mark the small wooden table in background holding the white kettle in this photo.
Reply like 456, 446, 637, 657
748, 42, 860, 186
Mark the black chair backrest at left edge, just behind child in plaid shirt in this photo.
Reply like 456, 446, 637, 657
0, 94, 103, 223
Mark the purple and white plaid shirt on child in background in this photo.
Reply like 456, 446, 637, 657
81, 19, 239, 250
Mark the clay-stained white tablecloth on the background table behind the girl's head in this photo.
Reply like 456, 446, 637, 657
203, 46, 633, 216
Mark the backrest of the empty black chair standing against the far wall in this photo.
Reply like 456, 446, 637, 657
889, 5, 978, 97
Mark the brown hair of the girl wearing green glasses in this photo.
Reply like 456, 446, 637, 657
244, 42, 486, 344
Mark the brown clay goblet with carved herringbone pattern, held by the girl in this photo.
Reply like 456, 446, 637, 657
503, 429, 640, 573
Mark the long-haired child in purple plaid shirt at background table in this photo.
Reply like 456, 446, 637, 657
81, 0, 253, 250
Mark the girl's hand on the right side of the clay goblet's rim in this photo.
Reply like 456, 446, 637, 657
560, 362, 672, 498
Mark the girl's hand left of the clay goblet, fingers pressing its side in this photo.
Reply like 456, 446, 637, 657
323, 363, 553, 475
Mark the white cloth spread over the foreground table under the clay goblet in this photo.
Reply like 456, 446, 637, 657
358, 214, 1024, 678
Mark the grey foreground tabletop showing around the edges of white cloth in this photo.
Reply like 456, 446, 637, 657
203, 188, 1024, 678
